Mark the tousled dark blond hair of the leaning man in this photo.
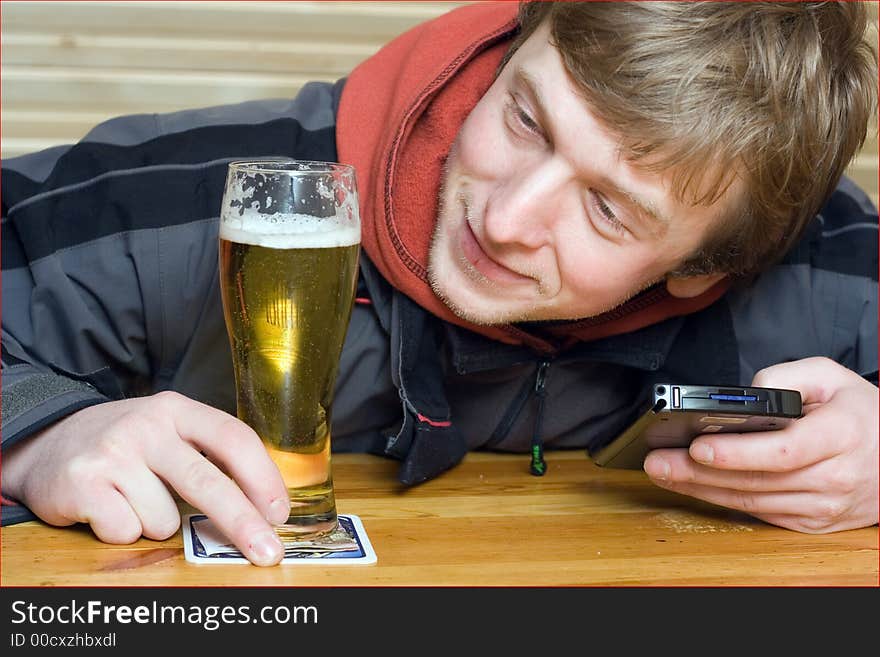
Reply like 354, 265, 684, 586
505, 2, 877, 275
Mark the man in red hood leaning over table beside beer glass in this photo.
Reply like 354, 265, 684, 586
3, 3, 878, 565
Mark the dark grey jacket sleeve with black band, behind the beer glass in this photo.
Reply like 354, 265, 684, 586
0, 81, 343, 524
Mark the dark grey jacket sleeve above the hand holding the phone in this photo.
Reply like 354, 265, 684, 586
728, 178, 878, 385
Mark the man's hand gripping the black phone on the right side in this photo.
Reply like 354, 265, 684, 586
645, 358, 880, 534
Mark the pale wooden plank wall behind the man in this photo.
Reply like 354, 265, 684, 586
0, 0, 878, 203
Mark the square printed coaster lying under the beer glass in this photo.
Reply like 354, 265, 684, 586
181, 513, 376, 565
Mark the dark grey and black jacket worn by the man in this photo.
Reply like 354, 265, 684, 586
2, 82, 878, 524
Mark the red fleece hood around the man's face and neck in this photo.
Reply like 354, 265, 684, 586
336, 2, 729, 352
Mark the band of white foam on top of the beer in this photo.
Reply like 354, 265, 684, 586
220, 212, 361, 249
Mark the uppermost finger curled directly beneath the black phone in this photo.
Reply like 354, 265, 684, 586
688, 414, 842, 472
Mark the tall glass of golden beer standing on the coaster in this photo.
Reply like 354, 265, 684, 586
220, 160, 360, 537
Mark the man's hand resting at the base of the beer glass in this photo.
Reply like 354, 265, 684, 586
3, 392, 290, 566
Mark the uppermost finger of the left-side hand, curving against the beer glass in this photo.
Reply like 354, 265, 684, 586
153, 395, 290, 525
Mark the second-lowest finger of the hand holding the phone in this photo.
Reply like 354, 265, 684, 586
656, 481, 845, 522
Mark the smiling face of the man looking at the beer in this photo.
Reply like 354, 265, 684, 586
428, 25, 730, 324
